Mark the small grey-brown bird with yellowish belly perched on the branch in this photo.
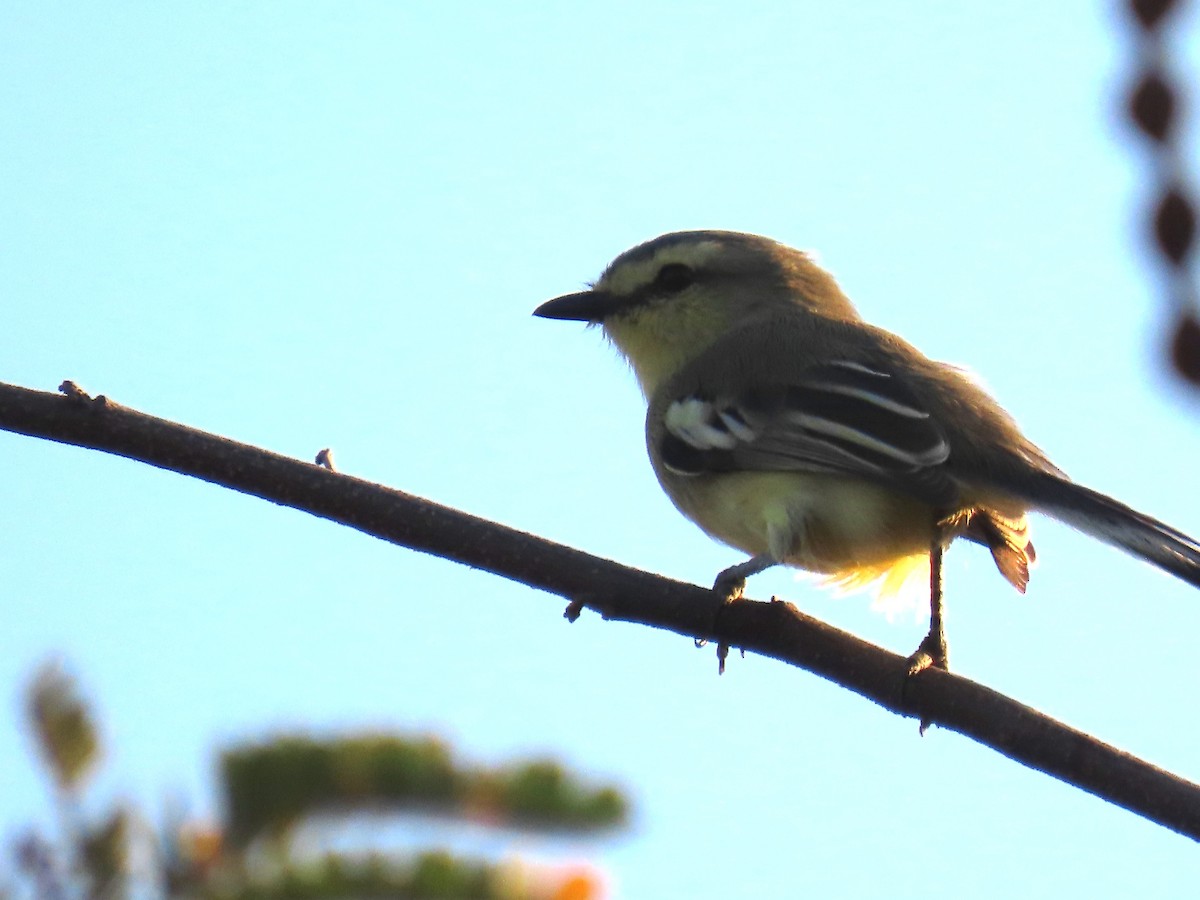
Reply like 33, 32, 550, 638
534, 230, 1200, 671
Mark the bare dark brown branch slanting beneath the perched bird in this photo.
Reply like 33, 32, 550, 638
0, 383, 1200, 840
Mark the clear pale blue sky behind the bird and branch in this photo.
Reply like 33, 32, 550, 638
7, 1, 1200, 900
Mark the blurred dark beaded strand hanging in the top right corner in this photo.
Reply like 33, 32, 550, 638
1128, 0, 1200, 388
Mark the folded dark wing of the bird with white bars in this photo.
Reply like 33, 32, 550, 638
659, 360, 953, 503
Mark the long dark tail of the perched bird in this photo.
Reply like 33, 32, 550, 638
1018, 474, 1200, 588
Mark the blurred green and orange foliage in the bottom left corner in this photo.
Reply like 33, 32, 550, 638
16, 664, 629, 900
